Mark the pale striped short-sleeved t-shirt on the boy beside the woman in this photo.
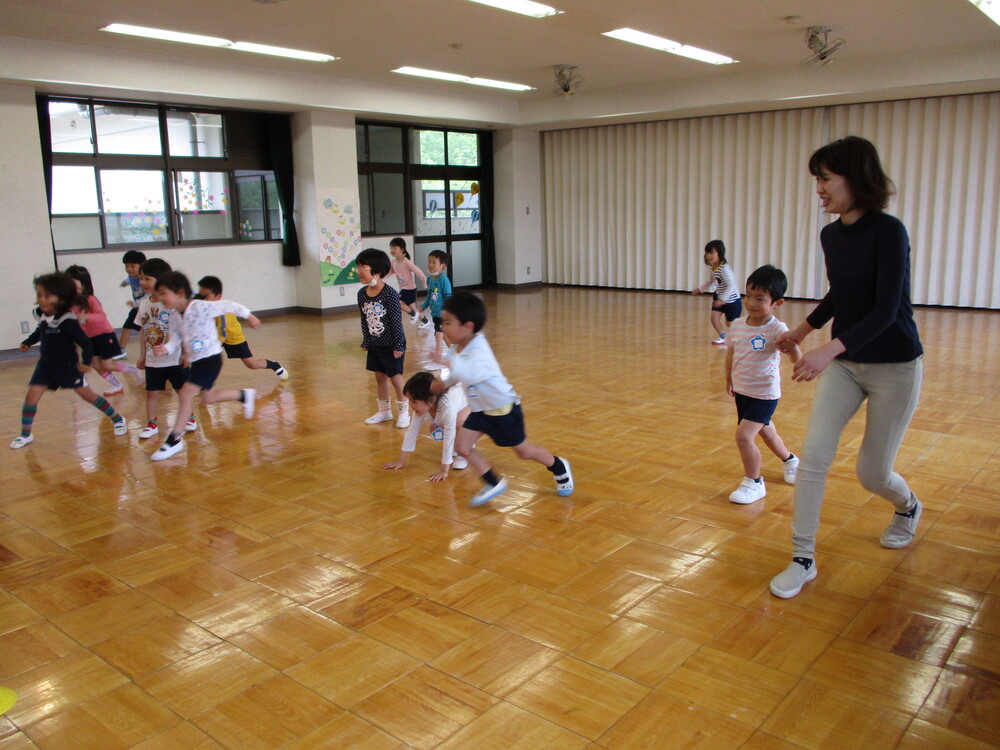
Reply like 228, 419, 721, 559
726, 316, 788, 401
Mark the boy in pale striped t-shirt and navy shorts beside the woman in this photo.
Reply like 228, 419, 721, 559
726, 266, 802, 505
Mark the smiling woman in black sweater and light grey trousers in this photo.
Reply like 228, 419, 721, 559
771, 136, 923, 599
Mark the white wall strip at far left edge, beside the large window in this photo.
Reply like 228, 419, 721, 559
0, 85, 64, 350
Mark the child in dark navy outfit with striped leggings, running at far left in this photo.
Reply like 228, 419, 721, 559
10, 271, 128, 450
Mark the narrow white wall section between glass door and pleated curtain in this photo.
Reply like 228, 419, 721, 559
493, 128, 545, 284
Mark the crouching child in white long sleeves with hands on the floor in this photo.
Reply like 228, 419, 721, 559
382, 372, 469, 482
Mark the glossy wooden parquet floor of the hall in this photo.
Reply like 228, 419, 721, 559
0, 287, 1000, 750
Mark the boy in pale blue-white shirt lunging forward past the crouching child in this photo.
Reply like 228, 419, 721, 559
431, 292, 573, 507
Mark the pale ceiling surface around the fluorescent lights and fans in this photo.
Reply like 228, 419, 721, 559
0, 0, 1000, 126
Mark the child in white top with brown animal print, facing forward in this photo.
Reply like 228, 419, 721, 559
135, 258, 198, 440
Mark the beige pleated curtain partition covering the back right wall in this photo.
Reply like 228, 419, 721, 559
542, 93, 1000, 309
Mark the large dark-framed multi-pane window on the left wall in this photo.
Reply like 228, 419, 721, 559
45, 98, 282, 251
